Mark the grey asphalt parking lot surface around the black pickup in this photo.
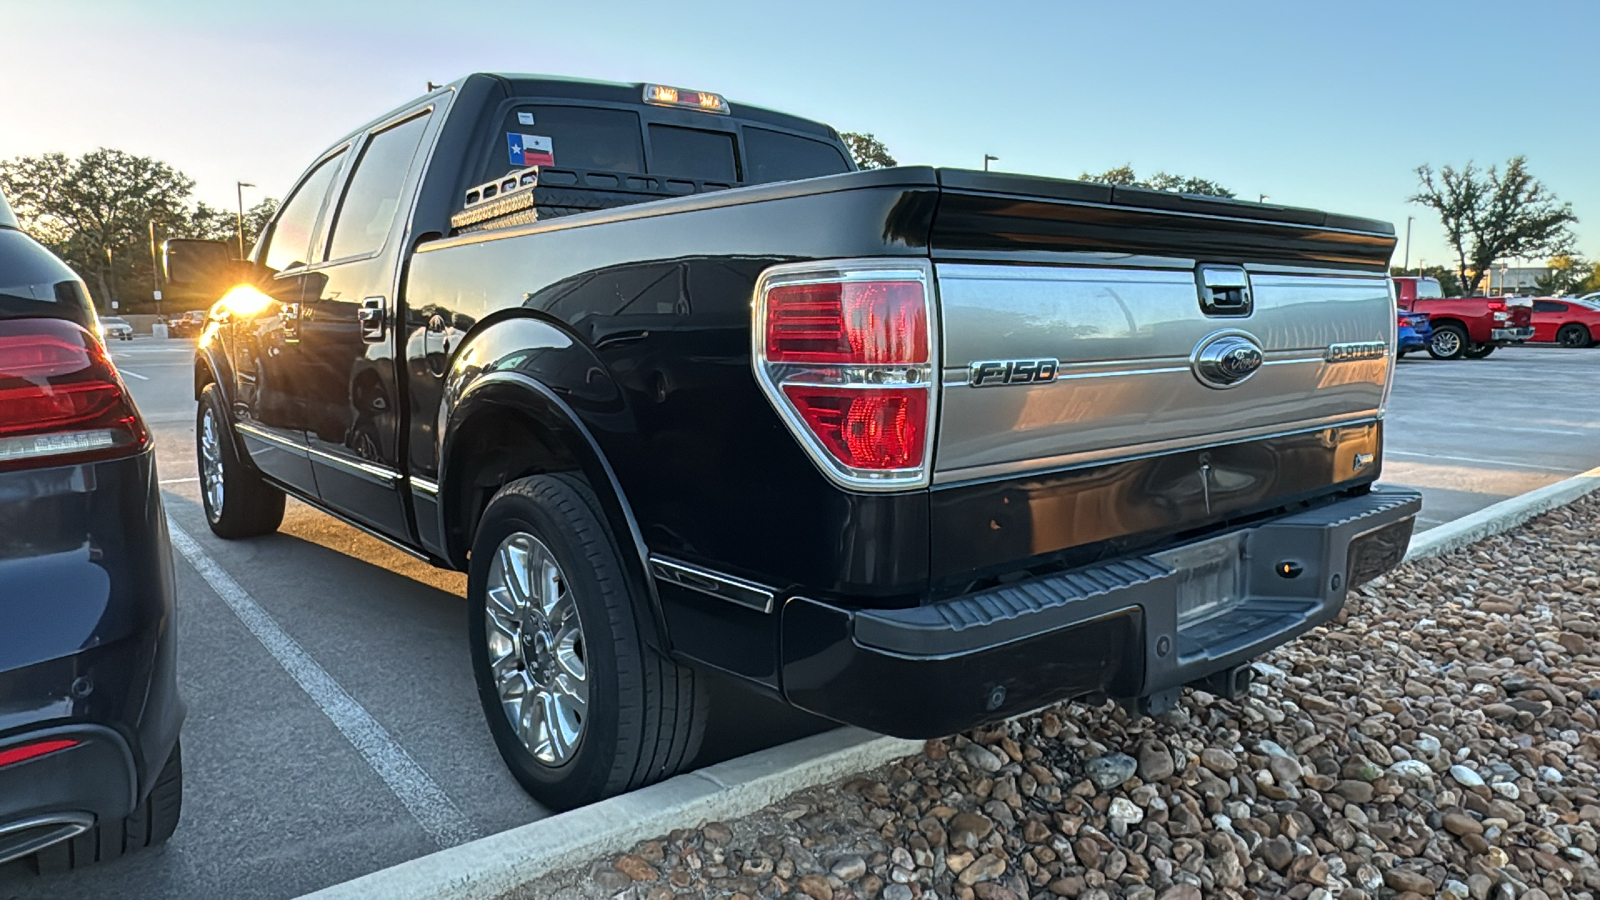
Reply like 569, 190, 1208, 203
0, 338, 1600, 898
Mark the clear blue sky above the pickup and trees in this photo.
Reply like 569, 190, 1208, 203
0, 0, 1600, 264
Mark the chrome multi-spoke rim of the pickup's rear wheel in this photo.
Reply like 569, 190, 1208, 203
485, 532, 589, 765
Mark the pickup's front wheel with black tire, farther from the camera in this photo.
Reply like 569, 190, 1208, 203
195, 384, 283, 541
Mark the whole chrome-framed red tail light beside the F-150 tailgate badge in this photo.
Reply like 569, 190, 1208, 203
752, 261, 938, 490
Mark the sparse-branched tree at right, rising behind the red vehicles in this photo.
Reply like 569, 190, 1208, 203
1411, 157, 1578, 297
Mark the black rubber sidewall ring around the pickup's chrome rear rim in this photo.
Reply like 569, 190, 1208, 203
467, 479, 638, 809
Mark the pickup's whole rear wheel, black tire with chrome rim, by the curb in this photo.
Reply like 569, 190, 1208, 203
467, 474, 709, 810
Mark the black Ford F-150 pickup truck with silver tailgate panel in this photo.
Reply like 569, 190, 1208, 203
195, 74, 1419, 807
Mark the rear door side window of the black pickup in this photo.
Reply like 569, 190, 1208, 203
328, 112, 429, 259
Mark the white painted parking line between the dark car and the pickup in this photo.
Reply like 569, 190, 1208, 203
166, 517, 478, 847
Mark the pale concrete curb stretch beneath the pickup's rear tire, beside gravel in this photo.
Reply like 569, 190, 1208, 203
306, 729, 923, 900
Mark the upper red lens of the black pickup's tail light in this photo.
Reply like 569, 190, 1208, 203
766, 282, 928, 365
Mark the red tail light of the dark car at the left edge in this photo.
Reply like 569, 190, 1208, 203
0, 319, 149, 471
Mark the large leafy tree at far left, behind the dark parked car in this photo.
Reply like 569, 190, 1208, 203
0, 147, 194, 310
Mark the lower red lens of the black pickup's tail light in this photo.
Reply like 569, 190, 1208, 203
784, 384, 928, 469
